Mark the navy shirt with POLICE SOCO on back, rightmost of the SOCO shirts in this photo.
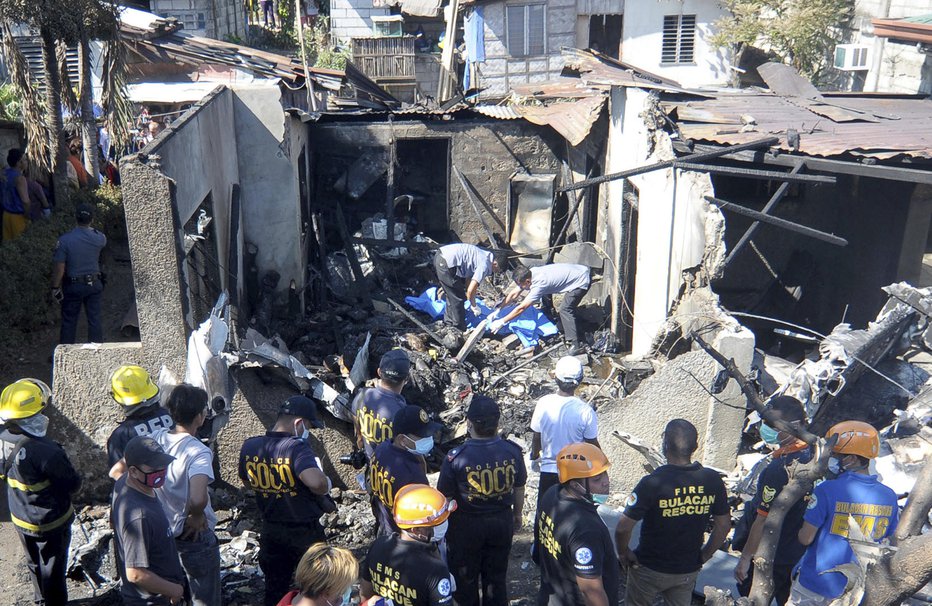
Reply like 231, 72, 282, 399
437, 436, 527, 514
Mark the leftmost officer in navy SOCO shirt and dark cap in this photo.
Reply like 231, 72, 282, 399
239, 396, 331, 606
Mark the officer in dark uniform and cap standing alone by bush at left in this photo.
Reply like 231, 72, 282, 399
52, 204, 107, 343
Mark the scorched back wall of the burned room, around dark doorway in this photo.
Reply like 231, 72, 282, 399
309, 119, 563, 243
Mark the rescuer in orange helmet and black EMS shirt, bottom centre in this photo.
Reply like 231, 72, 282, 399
359, 484, 457, 606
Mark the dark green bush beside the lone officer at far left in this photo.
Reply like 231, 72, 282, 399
0, 186, 126, 339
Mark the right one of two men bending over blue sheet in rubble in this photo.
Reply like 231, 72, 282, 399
489, 263, 589, 356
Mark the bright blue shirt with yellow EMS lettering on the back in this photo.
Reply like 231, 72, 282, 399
799, 471, 899, 598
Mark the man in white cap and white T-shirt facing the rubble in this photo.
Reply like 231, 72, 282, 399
531, 356, 601, 506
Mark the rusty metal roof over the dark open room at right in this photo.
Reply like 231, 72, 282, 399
661, 90, 932, 159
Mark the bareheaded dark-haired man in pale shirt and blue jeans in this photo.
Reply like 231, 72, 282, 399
152, 383, 221, 606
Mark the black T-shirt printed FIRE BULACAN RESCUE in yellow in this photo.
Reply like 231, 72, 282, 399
625, 463, 729, 574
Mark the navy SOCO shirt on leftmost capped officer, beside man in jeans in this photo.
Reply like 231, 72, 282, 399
239, 431, 323, 526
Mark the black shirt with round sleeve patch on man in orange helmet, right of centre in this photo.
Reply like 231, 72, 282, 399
534, 484, 618, 606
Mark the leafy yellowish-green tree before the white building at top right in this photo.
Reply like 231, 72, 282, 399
711, 0, 854, 84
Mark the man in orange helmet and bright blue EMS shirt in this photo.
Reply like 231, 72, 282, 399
789, 421, 899, 606
